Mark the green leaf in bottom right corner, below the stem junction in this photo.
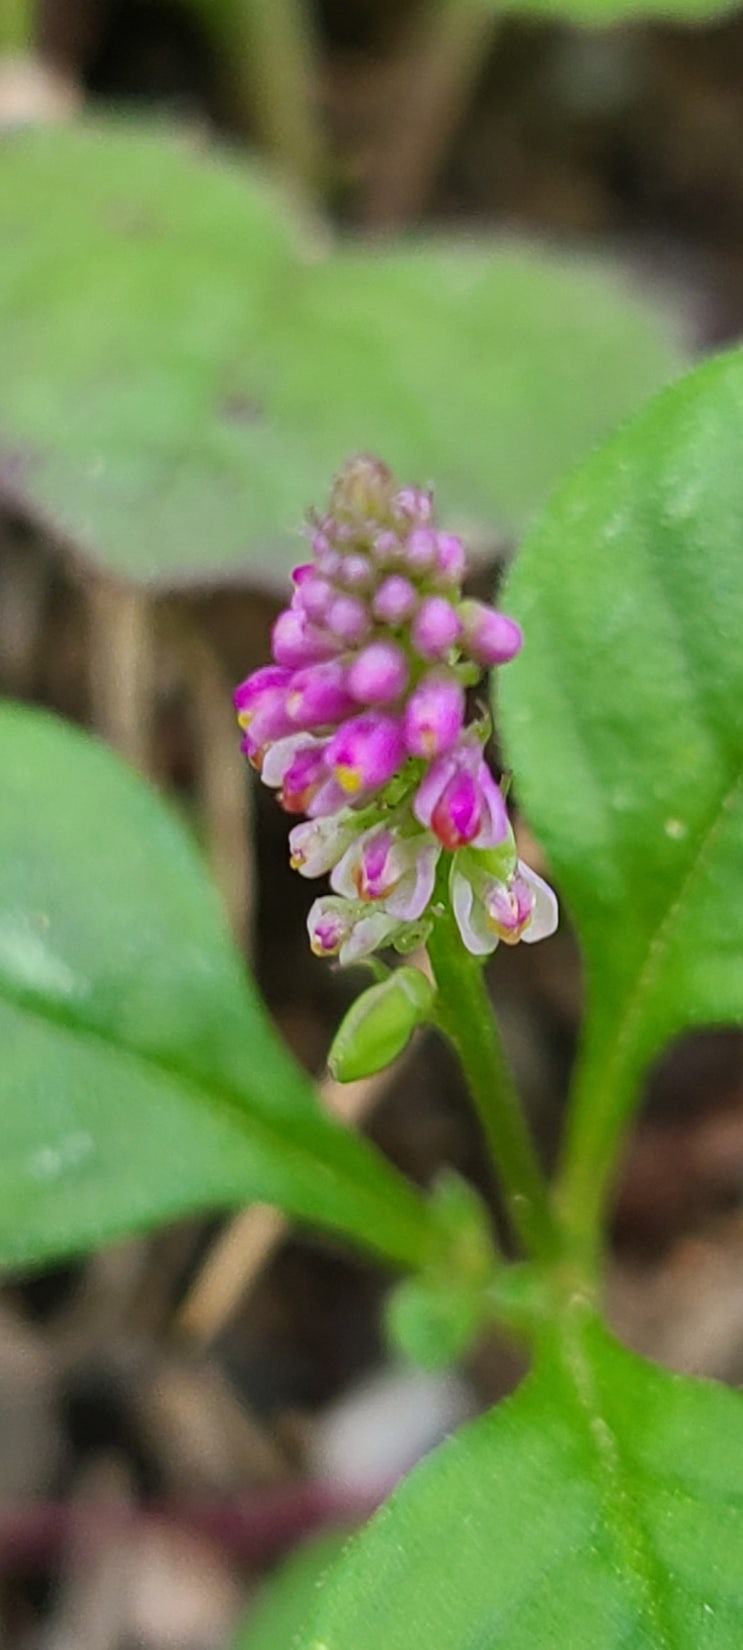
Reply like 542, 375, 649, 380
296, 1308, 743, 1650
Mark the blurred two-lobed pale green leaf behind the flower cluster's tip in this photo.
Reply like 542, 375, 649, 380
0, 124, 679, 586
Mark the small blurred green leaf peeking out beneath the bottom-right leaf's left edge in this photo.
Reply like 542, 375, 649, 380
233, 1530, 348, 1650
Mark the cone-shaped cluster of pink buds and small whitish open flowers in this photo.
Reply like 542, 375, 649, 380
234, 457, 556, 964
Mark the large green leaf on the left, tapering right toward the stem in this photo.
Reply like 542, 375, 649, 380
0, 706, 433, 1264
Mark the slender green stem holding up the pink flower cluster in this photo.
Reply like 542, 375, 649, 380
428, 911, 561, 1261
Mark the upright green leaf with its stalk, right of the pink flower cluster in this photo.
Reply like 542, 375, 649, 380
500, 351, 743, 1234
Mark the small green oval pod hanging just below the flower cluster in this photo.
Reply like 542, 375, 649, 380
327, 967, 436, 1082
